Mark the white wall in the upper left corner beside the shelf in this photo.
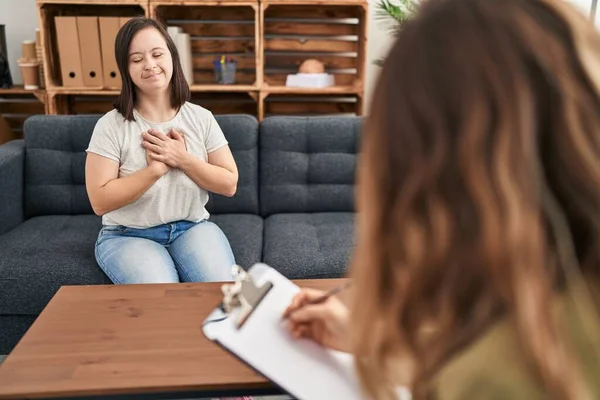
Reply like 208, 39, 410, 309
0, 0, 39, 83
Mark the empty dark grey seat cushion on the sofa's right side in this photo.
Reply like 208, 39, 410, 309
264, 213, 354, 279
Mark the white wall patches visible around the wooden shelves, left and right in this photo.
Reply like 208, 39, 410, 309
0, 0, 600, 110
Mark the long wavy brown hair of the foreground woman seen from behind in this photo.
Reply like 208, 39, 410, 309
351, 0, 600, 399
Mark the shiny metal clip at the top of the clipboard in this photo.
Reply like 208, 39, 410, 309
221, 265, 273, 329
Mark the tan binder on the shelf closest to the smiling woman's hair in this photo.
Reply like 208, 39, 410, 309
98, 17, 121, 89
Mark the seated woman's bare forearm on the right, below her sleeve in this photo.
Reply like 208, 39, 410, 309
180, 155, 238, 197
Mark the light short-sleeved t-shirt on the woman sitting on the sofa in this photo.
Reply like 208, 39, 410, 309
86, 102, 228, 228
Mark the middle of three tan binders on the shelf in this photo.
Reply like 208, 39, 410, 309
77, 17, 104, 87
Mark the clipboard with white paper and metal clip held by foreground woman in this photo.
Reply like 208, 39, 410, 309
202, 263, 365, 400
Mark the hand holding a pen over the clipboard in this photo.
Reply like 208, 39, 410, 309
283, 289, 350, 352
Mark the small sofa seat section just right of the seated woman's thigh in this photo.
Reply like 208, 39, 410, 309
210, 214, 263, 268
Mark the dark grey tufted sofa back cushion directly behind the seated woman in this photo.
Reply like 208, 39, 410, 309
23, 115, 259, 218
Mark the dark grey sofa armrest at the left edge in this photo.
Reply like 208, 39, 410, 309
0, 140, 25, 235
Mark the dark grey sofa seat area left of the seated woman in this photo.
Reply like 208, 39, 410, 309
0, 215, 110, 315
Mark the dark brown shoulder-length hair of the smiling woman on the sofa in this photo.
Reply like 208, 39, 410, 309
114, 17, 190, 121
